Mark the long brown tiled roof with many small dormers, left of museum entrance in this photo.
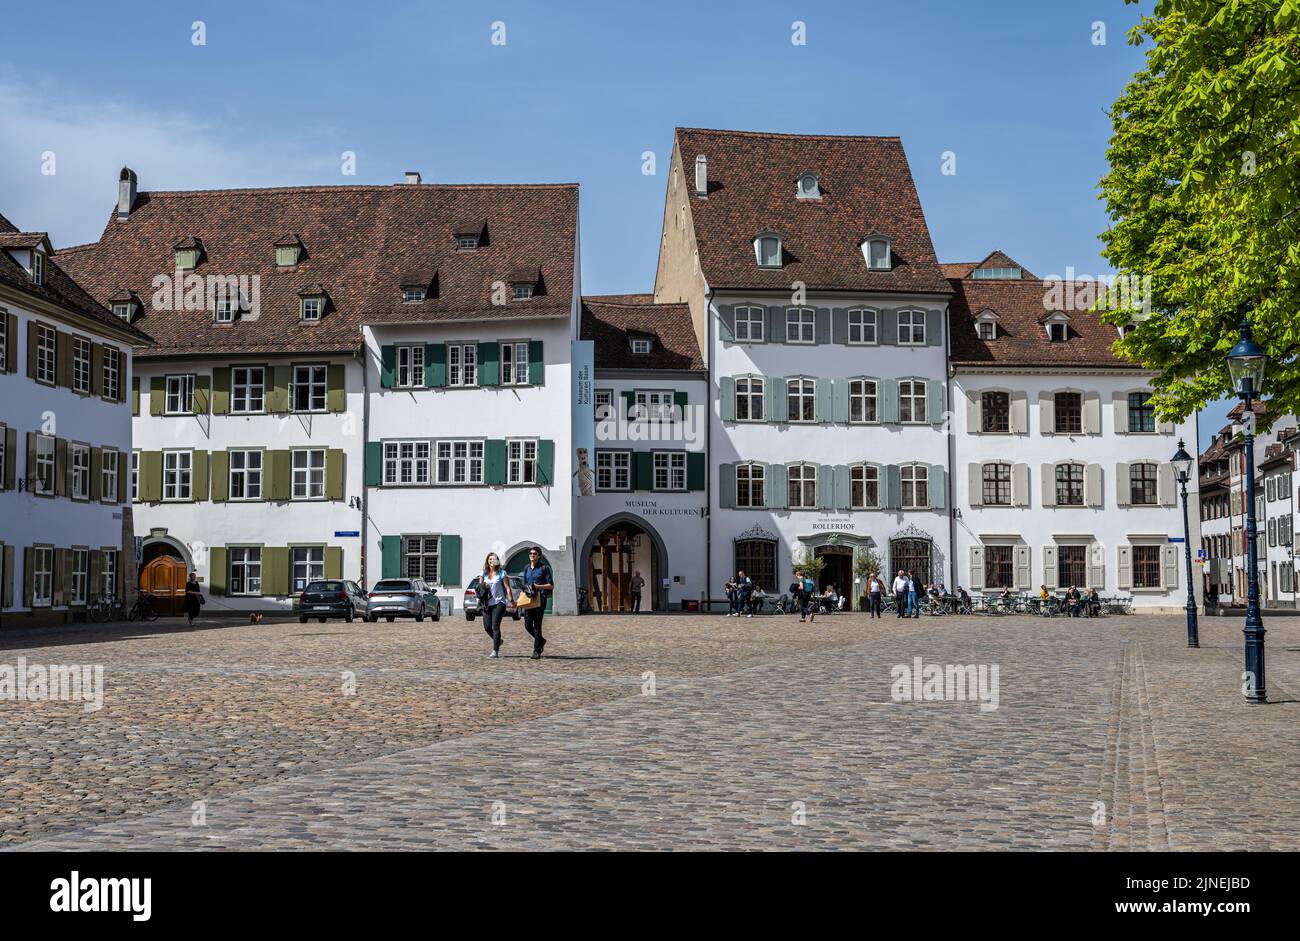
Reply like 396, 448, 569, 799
59, 183, 577, 354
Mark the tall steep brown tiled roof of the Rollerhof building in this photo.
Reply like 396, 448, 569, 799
670, 127, 949, 294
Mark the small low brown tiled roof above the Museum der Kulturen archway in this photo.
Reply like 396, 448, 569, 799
581, 294, 705, 370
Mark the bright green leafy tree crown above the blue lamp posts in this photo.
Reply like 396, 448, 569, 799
1101, 0, 1300, 421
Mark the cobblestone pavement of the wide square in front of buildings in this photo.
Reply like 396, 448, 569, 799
0, 615, 1300, 850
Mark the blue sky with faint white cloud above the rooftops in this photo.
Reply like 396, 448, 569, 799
0, 0, 1222, 437
